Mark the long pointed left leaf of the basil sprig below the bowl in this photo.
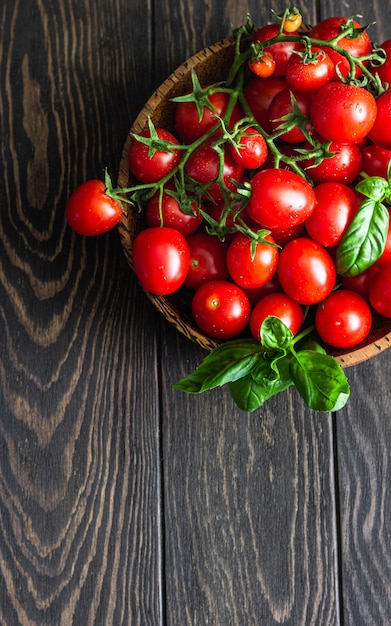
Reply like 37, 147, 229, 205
174, 339, 264, 393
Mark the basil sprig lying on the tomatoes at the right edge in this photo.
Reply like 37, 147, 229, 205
336, 168, 391, 276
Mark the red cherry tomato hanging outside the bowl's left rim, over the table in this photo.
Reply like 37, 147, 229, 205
65, 180, 122, 235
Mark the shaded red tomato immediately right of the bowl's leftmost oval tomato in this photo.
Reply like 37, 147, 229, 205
185, 233, 229, 290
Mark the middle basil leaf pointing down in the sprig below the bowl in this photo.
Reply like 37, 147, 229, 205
229, 374, 292, 412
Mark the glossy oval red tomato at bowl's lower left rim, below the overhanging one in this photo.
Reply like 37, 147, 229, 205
132, 227, 190, 296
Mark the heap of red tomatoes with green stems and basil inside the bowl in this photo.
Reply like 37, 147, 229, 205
67, 10, 391, 348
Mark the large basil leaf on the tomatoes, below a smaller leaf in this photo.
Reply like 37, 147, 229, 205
336, 198, 389, 276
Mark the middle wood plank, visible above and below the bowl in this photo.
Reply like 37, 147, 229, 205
156, 1, 339, 626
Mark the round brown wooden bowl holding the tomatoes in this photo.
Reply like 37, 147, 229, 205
118, 38, 391, 367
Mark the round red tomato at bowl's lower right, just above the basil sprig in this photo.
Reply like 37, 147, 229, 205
315, 289, 372, 348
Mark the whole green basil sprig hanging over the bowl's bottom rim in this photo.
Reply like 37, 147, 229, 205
174, 316, 350, 411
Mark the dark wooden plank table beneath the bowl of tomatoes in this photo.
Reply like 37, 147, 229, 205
0, 0, 391, 626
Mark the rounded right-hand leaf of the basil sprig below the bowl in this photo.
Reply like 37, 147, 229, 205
290, 350, 350, 411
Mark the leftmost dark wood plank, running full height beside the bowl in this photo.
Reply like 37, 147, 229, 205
0, 0, 162, 626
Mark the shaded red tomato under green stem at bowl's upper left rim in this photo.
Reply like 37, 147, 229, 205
175, 91, 243, 143
